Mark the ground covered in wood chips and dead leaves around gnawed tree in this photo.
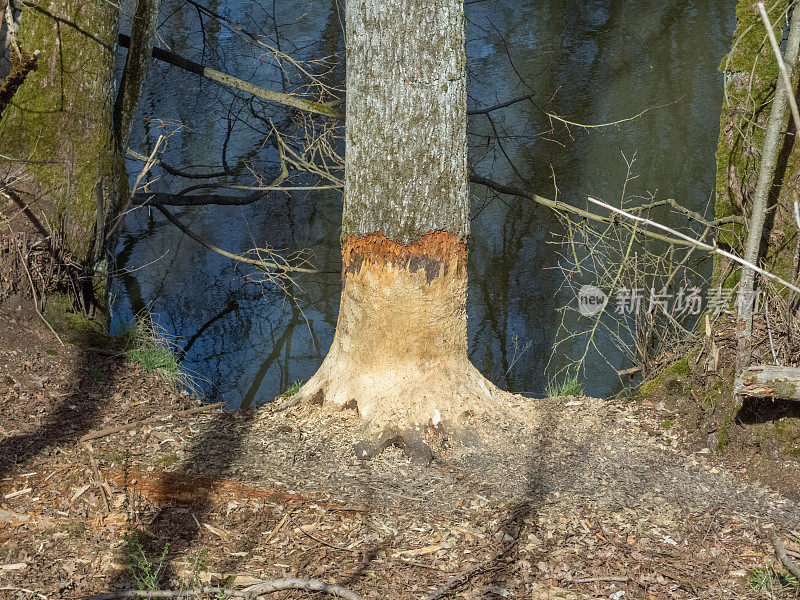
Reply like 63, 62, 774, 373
0, 302, 800, 600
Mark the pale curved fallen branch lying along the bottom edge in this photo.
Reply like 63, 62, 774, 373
86, 577, 363, 600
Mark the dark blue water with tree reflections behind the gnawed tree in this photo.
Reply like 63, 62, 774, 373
113, 0, 735, 406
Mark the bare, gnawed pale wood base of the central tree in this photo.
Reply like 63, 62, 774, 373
278, 232, 497, 460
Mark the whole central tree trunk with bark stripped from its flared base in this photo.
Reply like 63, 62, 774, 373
288, 0, 496, 457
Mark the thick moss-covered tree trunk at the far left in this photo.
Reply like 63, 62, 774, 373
0, 0, 118, 265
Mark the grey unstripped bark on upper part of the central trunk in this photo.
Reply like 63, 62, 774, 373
342, 0, 469, 244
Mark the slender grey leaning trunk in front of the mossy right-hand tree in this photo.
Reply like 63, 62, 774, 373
734, 10, 800, 393
